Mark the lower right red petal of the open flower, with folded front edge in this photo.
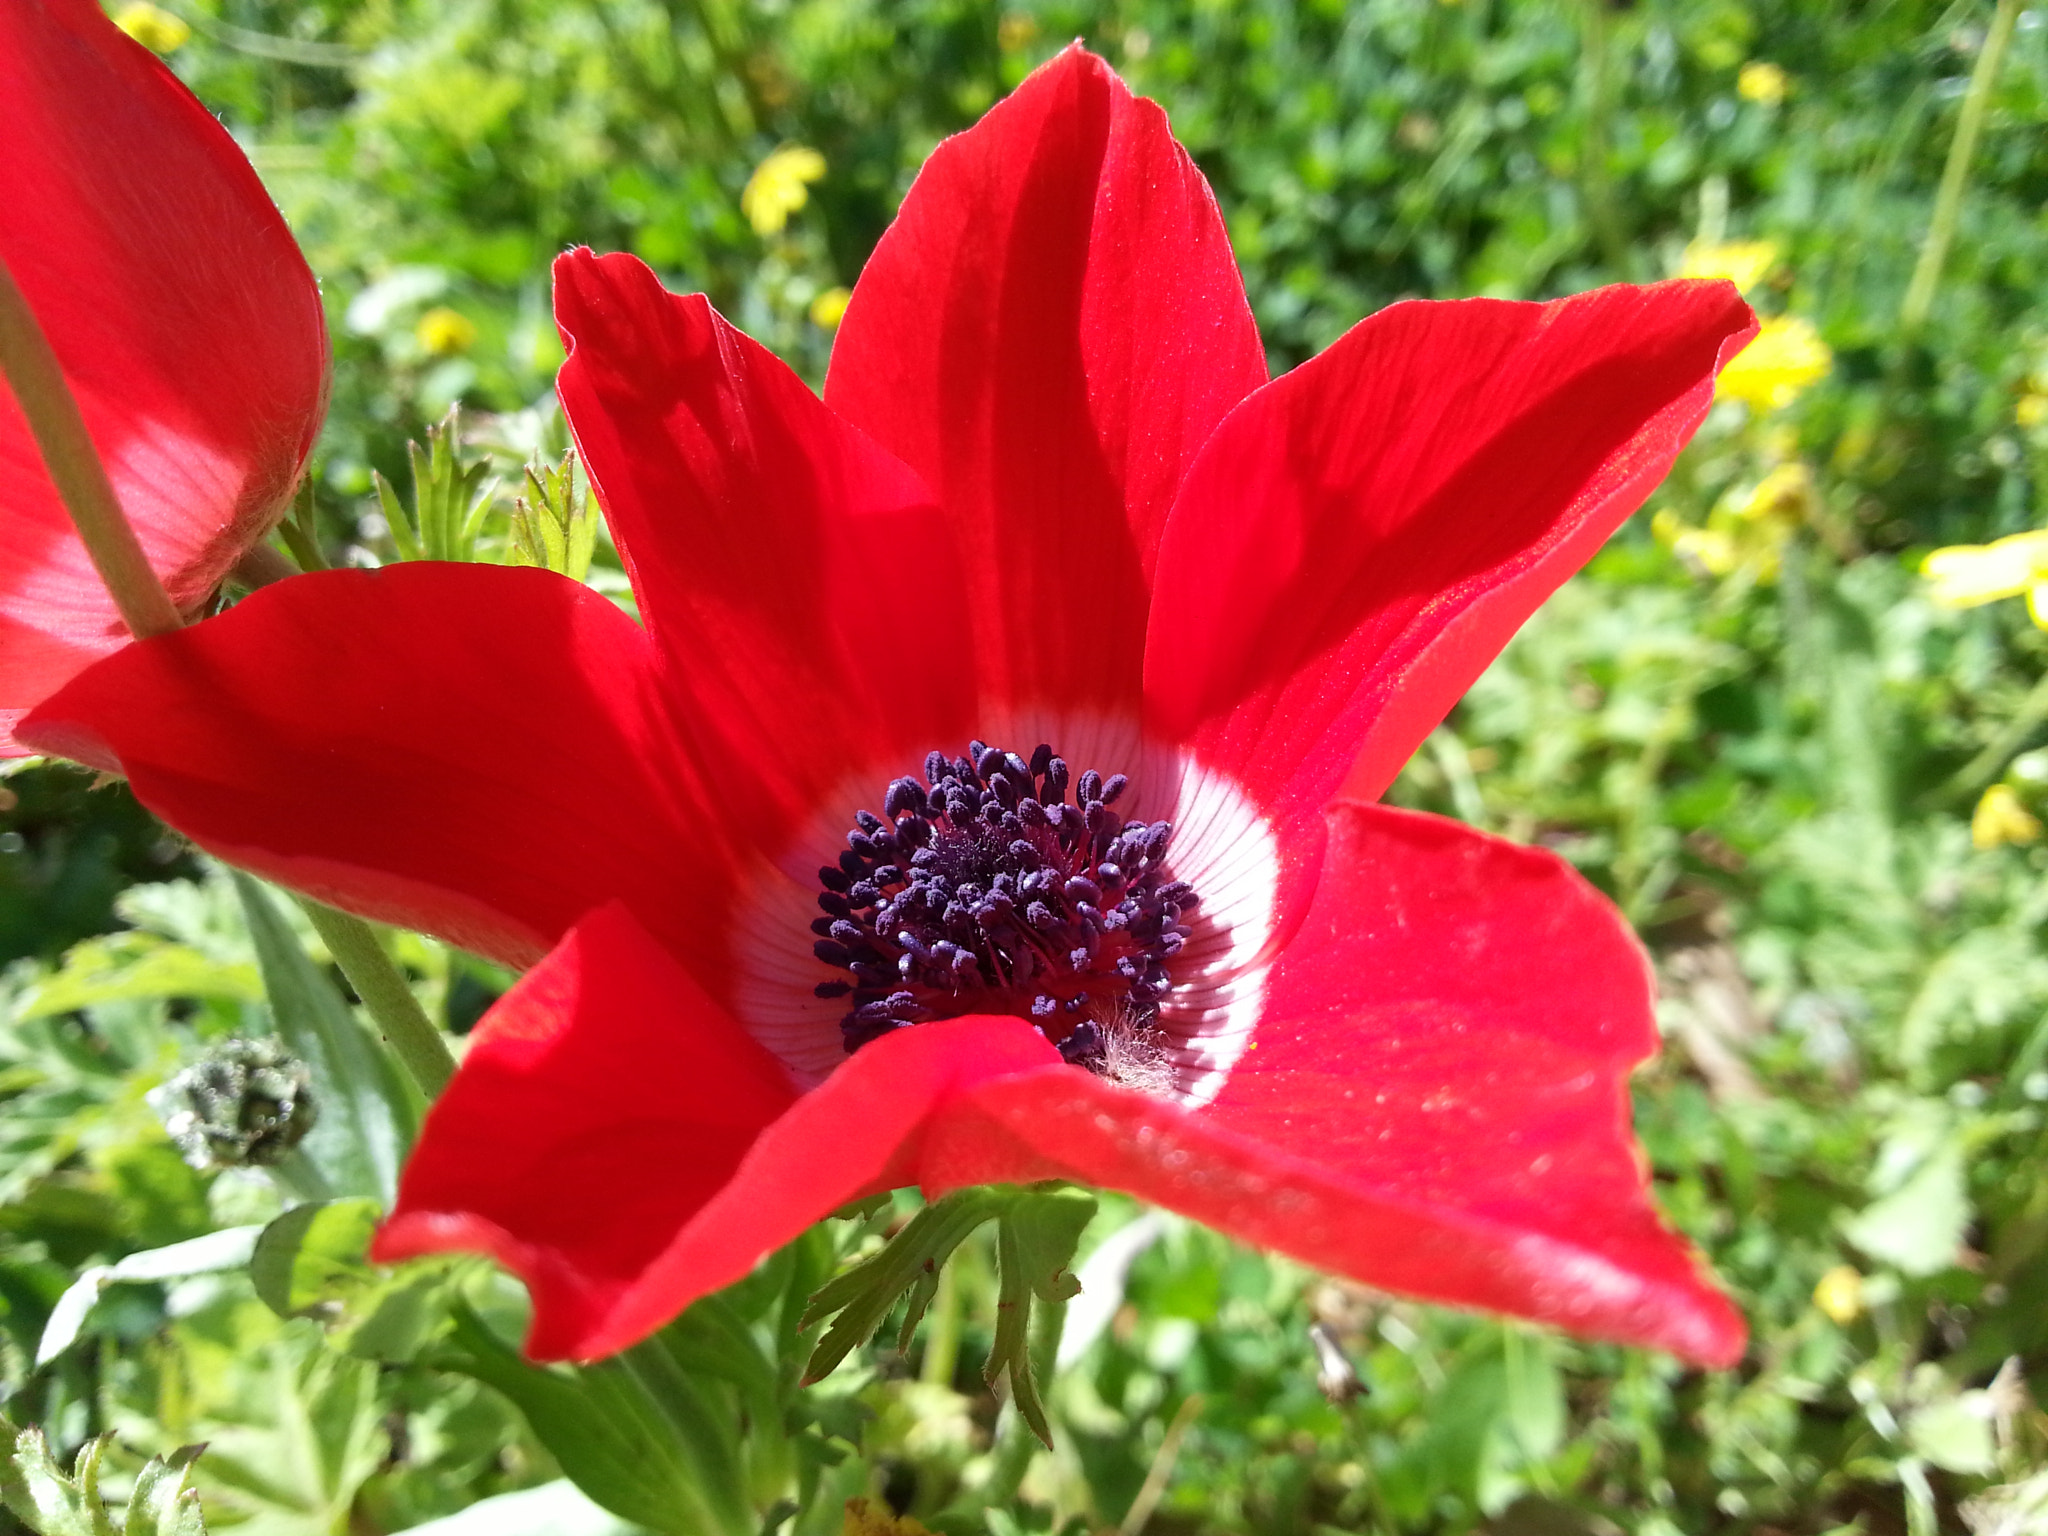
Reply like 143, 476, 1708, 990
920, 805, 1743, 1366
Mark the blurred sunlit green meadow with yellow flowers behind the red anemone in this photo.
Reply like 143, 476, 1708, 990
0, 0, 2048, 1536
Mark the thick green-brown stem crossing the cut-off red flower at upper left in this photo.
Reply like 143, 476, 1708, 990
0, 260, 184, 639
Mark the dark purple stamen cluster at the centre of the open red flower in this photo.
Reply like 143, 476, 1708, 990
811, 741, 1198, 1077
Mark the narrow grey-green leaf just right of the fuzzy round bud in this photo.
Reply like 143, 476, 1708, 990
236, 872, 418, 1206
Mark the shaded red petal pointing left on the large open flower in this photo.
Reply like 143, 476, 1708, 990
23, 563, 712, 965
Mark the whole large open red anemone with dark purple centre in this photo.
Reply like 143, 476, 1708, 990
29, 49, 1753, 1364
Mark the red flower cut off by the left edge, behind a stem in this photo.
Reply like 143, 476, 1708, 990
0, 0, 328, 756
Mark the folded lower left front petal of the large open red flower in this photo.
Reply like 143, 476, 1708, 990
375, 907, 1077, 1360
